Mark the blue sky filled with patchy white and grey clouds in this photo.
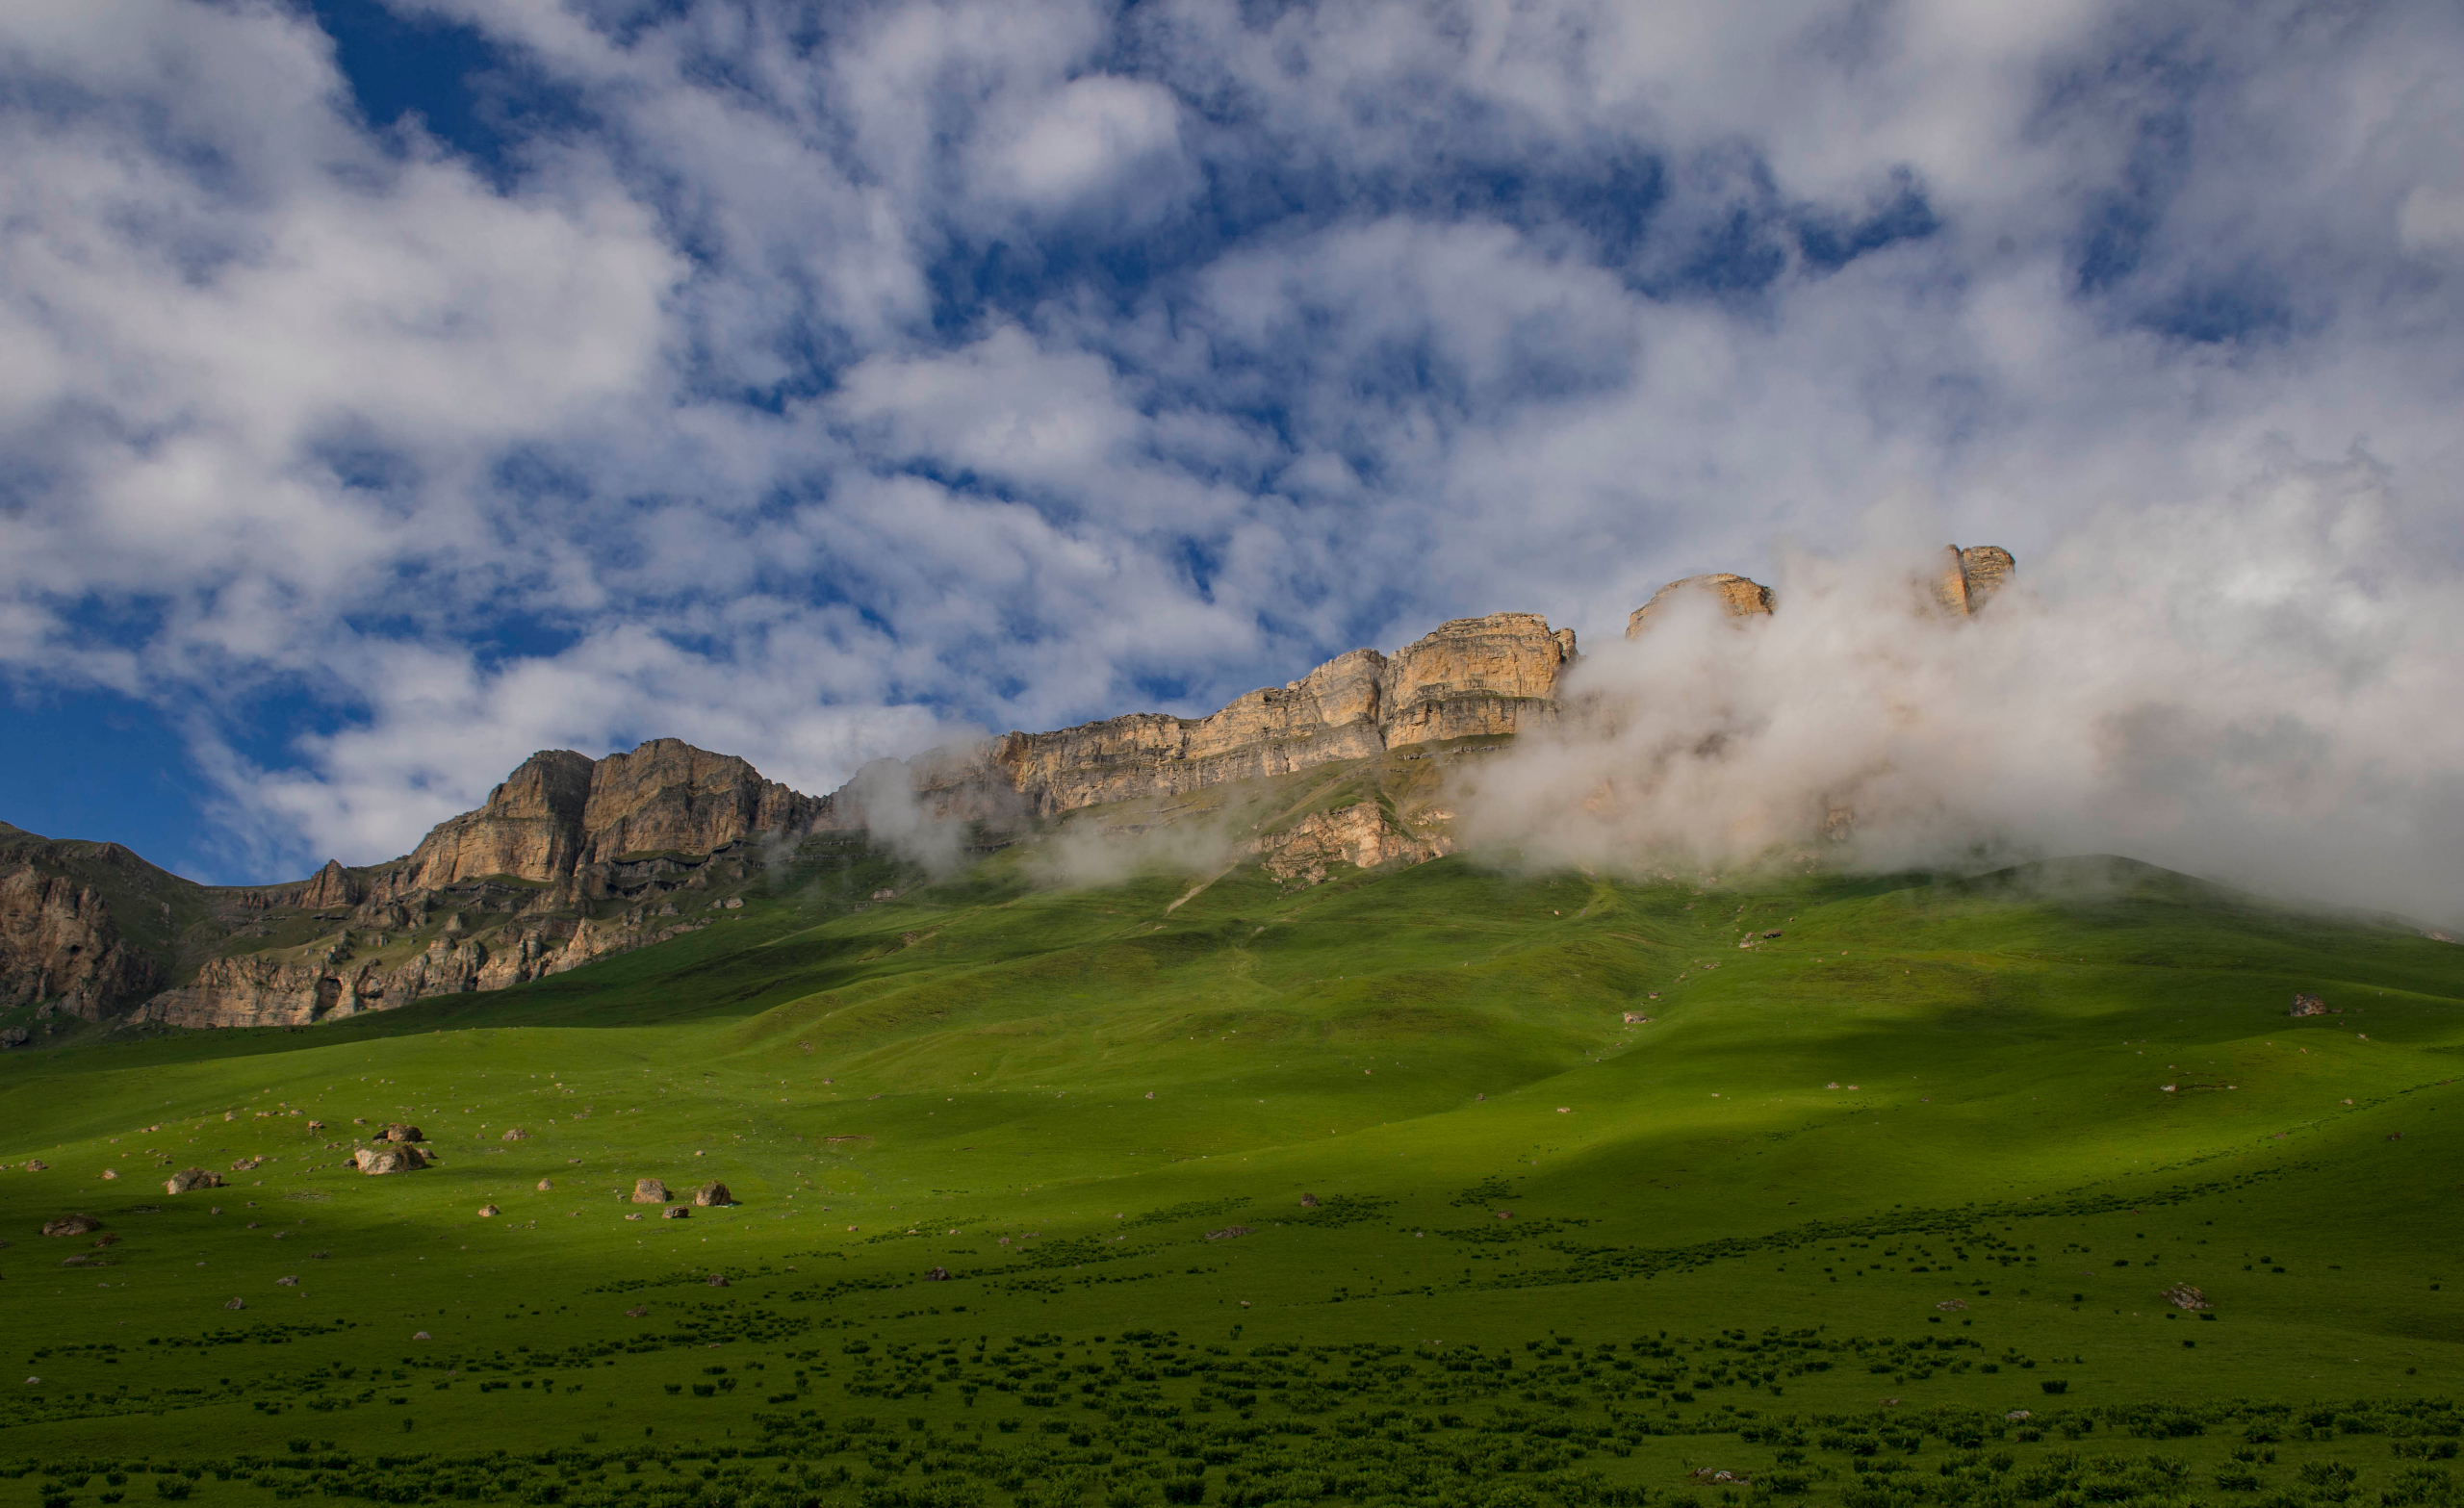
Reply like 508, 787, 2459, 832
0, 0, 2464, 882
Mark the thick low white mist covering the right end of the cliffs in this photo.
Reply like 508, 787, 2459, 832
1459, 461, 2464, 922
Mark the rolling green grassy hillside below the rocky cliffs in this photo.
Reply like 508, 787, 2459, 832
0, 848, 2464, 1508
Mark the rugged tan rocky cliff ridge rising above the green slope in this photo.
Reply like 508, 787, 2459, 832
0, 547, 2014, 1042
